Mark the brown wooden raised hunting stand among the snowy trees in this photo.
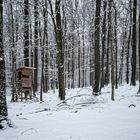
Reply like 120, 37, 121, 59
16, 67, 34, 101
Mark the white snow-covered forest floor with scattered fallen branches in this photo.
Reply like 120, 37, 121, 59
0, 85, 140, 140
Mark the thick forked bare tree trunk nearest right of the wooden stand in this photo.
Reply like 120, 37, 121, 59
49, 0, 65, 100
